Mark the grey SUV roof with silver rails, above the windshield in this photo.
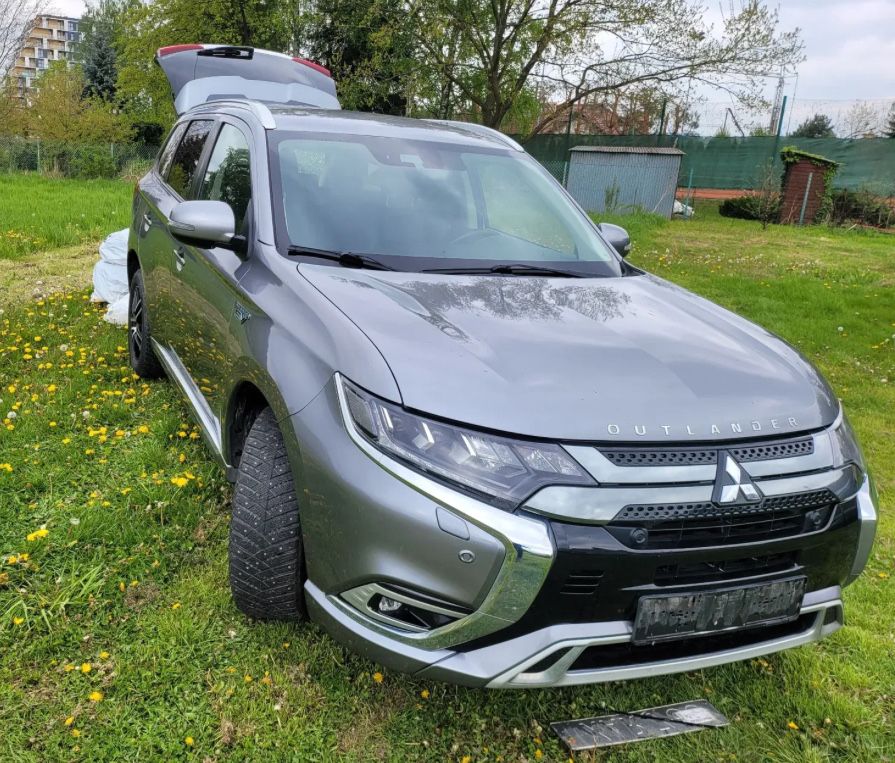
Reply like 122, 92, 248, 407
183, 99, 524, 151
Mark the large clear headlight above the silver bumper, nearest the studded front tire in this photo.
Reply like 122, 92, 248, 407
337, 377, 594, 508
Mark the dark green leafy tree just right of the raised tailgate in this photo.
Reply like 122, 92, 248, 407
298, 0, 414, 115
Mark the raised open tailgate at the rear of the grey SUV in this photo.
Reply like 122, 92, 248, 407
155, 43, 340, 116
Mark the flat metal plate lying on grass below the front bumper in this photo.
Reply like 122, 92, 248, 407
550, 699, 730, 751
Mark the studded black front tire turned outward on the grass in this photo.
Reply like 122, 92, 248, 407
230, 408, 307, 621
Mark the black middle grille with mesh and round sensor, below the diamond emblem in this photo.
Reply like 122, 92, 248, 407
606, 490, 836, 549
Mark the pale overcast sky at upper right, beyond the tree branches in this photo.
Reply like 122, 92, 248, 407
52, 0, 895, 113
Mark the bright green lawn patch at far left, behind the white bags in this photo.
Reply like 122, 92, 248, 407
0, 175, 133, 260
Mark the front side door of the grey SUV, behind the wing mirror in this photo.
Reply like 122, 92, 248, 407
171, 117, 254, 414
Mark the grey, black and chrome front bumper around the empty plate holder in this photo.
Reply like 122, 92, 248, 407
294, 385, 876, 688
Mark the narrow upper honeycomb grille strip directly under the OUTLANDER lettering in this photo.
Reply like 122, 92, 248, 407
600, 437, 814, 466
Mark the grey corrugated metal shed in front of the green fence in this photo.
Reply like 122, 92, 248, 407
566, 146, 684, 217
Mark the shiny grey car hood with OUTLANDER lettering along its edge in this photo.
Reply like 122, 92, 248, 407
299, 264, 839, 442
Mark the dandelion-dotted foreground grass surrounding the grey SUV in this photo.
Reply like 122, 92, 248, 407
0, 197, 895, 762
